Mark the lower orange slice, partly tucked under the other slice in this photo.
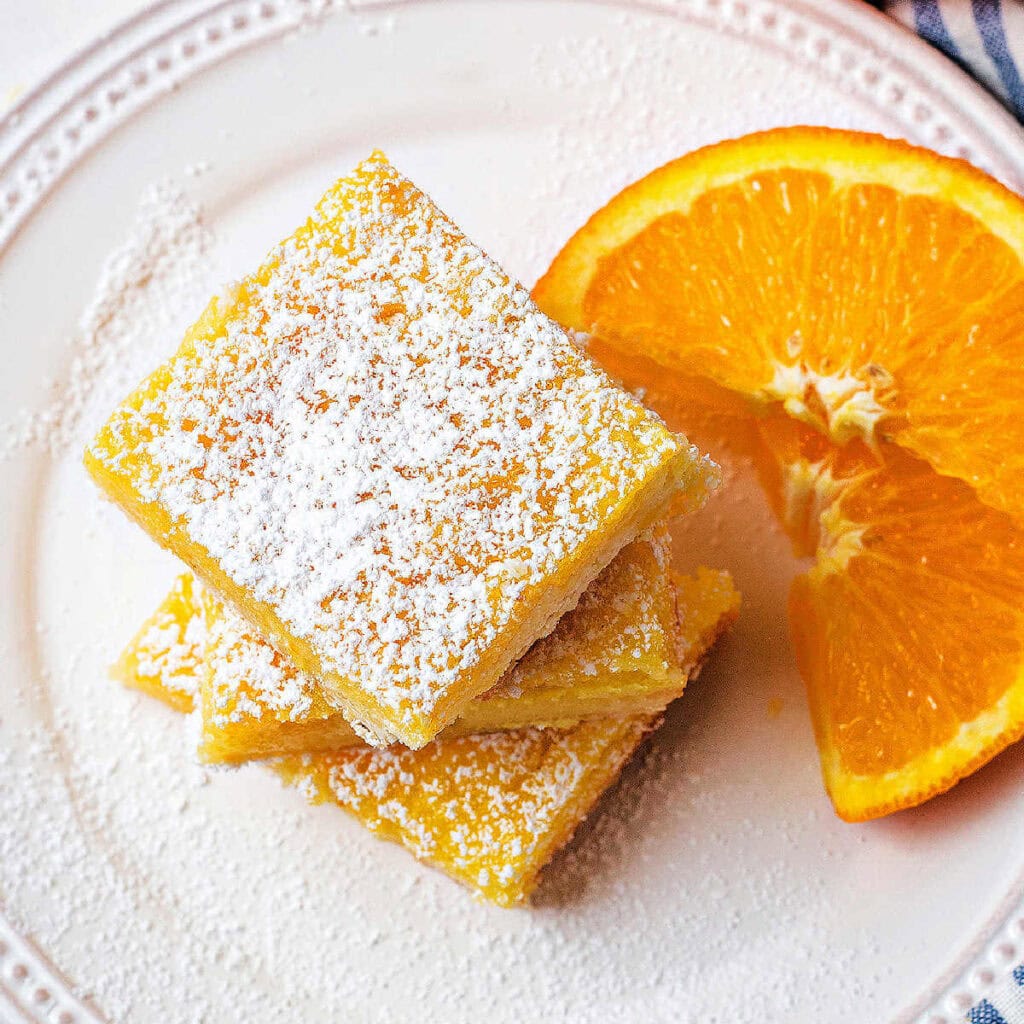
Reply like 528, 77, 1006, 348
762, 416, 1024, 819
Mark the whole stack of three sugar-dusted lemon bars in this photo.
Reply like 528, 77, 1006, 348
85, 155, 738, 905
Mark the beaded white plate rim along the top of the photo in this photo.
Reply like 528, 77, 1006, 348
0, 0, 1024, 254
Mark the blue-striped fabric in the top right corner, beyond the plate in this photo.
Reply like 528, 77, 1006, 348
879, 0, 1024, 121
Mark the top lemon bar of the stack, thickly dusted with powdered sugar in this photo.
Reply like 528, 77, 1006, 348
85, 149, 715, 748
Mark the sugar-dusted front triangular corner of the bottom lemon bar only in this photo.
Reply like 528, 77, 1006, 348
281, 717, 652, 905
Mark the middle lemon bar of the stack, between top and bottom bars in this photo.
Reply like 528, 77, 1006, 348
115, 529, 729, 763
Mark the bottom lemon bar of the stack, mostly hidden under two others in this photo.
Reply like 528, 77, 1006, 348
119, 569, 739, 906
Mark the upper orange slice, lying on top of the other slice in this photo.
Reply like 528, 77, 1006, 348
535, 128, 1024, 515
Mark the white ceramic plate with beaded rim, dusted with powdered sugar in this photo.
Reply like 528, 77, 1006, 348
0, 0, 1024, 1024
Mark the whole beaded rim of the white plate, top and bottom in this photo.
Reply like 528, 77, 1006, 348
0, 0, 1024, 1024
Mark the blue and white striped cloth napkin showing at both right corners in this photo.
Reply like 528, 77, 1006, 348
874, 0, 1024, 1024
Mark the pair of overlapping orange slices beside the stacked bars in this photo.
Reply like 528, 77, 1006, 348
535, 128, 1024, 820
